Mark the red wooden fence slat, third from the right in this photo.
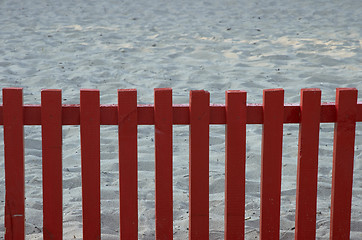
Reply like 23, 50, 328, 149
260, 89, 284, 240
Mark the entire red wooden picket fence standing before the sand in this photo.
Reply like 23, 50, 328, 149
0, 88, 362, 240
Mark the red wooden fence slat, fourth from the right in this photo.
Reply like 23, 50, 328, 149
224, 91, 246, 240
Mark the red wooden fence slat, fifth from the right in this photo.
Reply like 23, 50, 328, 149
189, 91, 210, 240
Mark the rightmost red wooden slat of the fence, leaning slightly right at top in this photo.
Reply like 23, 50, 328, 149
330, 88, 358, 240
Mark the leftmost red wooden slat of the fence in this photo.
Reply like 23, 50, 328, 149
3, 88, 25, 240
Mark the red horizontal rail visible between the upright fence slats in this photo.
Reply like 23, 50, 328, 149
0, 102, 362, 125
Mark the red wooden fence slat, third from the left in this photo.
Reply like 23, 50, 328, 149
80, 90, 101, 239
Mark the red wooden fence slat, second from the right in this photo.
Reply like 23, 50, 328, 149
295, 89, 321, 240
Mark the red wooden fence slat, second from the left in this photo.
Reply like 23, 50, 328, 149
41, 90, 63, 240
